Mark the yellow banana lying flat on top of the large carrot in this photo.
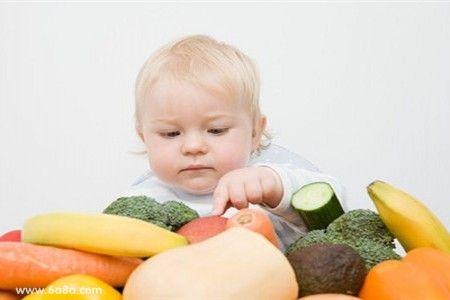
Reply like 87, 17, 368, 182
22, 213, 188, 257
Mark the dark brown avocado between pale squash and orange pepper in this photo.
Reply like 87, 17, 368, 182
287, 244, 367, 297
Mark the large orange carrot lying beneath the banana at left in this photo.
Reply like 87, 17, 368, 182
0, 242, 142, 290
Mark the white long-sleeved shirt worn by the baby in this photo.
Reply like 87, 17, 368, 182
120, 144, 345, 250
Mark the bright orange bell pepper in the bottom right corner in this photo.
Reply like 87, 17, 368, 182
359, 248, 450, 300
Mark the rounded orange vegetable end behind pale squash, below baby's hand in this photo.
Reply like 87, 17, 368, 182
227, 208, 279, 247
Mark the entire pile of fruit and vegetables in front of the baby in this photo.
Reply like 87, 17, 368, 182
0, 181, 450, 300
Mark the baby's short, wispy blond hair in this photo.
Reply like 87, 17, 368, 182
135, 35, 271, 152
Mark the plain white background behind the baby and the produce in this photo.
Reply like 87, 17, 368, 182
0, 2, 450, 233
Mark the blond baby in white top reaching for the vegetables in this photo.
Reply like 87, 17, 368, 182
126, 35, 342, 247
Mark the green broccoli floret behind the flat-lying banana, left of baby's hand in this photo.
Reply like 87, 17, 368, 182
103, 196, 198, 231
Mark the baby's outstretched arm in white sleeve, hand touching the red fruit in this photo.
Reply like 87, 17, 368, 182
213, 145, 344, 227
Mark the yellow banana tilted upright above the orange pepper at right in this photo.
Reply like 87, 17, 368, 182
367, 181, 450, 253
